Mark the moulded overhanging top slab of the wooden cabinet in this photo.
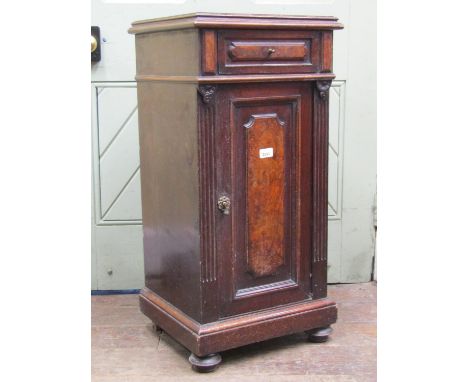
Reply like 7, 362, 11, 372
129, 13, 343, 34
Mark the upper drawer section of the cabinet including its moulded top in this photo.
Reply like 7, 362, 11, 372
131, 14, 342, 82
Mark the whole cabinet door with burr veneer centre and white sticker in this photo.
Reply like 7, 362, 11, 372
216, 83, 312, 316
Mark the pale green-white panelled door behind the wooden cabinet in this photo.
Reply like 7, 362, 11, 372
91, 0, 376, 290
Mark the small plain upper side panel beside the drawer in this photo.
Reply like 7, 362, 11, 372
135, 29, 200, 76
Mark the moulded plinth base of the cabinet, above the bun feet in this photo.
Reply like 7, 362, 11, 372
140, 288, 337, 357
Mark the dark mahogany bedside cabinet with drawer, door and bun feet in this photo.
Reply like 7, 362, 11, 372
129, 14, 342, 371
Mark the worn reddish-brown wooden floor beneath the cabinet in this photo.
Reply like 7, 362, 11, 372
91, 283, 377, 382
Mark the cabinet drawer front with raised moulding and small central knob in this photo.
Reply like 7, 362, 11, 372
218, 31, 321, 74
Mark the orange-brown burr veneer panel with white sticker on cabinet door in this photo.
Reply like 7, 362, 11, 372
244, 113, 291, 276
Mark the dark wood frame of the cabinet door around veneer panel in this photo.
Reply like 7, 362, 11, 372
216, 83, 312, 316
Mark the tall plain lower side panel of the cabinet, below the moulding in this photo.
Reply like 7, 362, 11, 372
138, 82, 200, 320
